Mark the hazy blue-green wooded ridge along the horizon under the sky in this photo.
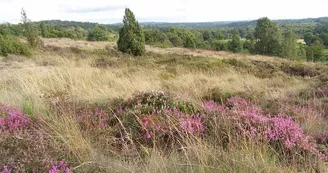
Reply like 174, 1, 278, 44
36, 17, 328, 30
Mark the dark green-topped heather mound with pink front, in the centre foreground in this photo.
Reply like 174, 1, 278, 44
111, 91, 203, 144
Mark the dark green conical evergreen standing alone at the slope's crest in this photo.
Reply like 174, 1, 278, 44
117, 8, 145, 56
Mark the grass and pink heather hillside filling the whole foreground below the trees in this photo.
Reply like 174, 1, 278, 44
0, 39, 328, 173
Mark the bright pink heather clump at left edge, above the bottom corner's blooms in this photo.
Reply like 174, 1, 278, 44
0, 105, 30, 133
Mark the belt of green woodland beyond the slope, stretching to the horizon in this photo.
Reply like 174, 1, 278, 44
0, 17, 328, 61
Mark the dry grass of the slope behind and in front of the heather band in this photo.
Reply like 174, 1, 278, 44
0, 39, 328, 172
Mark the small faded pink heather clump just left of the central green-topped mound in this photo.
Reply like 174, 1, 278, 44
77, 108, 109, 130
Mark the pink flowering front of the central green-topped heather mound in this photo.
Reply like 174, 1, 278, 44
142, 108, 204, 139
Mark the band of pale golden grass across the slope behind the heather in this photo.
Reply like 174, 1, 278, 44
0, 52, 309, 113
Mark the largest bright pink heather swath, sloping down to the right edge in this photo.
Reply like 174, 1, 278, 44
203, 97, 326, 158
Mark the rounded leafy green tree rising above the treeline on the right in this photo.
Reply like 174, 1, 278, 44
254, 17, 281, 56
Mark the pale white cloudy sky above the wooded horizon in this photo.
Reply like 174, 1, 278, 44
0, 0, 328, 24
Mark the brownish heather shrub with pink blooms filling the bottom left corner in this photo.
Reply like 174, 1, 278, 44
0, 105, 69, 172
